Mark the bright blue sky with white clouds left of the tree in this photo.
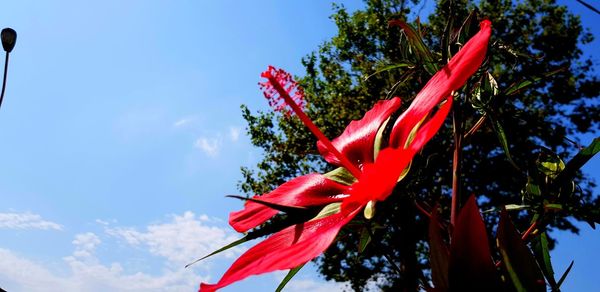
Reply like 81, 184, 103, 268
0, 0, 600, 291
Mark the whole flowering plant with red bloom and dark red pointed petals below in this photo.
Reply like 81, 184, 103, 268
193, 10, 597, 291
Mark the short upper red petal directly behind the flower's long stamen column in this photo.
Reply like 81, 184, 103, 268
317, 97, 401, 168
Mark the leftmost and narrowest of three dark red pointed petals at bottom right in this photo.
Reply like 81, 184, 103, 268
429, 206, 450, 291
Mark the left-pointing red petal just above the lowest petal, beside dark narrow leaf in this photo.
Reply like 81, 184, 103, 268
229, 173, 348, 232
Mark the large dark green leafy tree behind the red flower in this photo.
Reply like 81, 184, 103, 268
239, 0, 600, 291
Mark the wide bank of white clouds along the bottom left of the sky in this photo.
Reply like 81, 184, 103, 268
0, 212, 240, 292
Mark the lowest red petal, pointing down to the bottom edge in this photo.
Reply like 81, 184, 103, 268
200, 205, 362, 292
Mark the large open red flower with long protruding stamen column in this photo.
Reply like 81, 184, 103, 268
200, 20, 491, 291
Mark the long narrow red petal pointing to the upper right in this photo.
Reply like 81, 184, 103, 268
390, 20, 491, 147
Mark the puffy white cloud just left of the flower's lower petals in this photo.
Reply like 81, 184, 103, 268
106, 211, 239, 266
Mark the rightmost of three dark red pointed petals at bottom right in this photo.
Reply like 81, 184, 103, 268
497, 210, 546, 292
